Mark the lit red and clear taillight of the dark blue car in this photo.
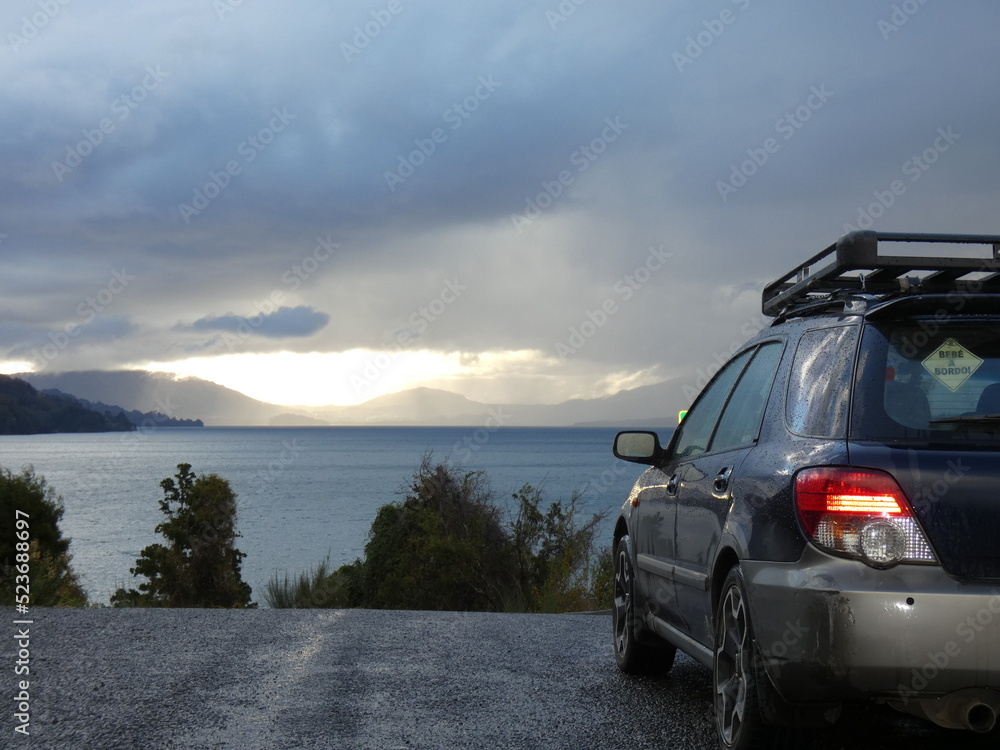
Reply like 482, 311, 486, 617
795, 466, 937, 568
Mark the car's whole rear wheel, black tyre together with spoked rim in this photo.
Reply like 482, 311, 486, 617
712, 566, 790, 750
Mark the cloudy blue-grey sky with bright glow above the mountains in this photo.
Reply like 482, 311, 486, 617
0, 0, 1000, 404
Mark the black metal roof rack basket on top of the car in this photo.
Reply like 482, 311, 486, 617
761, 231, 1000, 318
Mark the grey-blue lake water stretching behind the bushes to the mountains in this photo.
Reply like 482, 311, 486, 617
0, 427, 656, 604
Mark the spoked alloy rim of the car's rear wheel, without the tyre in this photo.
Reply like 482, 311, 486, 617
715, 586, 750, 744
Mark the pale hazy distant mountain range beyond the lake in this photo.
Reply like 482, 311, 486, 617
17, 370, 688, 429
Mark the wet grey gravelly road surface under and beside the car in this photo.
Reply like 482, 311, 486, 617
0, 609, 997, 750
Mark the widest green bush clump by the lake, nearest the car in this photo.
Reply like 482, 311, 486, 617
266, 456, 612, 612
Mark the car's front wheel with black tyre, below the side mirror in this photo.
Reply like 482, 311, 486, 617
611, 536, 677, 675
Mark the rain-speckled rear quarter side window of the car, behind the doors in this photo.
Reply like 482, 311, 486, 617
785, 326, 858, 438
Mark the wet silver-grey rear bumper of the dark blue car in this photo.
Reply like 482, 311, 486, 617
741, 546, 1000, 702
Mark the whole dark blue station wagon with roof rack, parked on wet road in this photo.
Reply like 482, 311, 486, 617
613, 232, 1000, 749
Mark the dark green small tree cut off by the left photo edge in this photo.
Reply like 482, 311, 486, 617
0, 468, 87, 607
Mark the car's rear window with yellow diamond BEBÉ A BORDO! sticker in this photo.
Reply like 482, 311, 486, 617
851, 318, 1000, 445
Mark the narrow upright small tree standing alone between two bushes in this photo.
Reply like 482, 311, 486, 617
111, 464, 254, 608
